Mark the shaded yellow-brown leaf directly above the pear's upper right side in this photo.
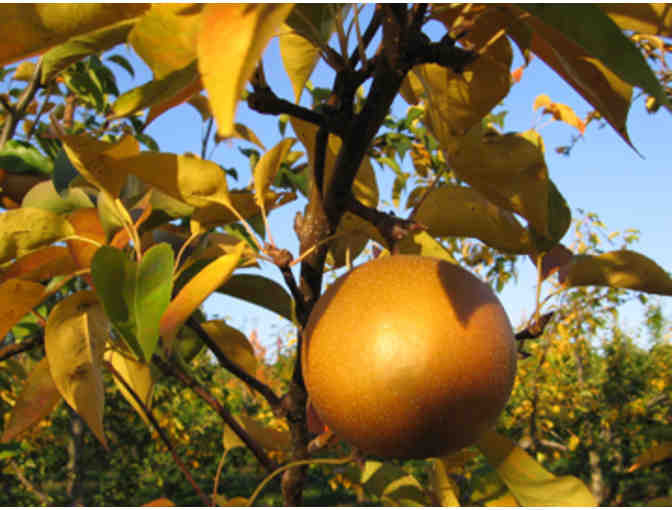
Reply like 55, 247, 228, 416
415, 184, 532, 253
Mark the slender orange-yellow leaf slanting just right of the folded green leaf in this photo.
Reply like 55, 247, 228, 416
159, 242, 245, 342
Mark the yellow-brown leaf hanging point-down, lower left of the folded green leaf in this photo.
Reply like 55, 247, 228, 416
44, 291, 109, 449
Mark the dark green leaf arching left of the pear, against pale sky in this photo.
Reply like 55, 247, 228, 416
217, 274, 294, 321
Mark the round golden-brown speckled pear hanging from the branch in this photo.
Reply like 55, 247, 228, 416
301, 255, 516, 459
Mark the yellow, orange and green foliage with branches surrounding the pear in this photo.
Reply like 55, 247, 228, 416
0, 4, 672, 506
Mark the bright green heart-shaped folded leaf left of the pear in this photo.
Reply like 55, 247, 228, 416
91, 243, 173, 361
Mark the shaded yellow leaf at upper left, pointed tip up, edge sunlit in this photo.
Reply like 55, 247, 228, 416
60, 135, 140, 198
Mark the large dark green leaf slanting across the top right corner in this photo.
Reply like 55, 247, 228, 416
520, 4, 670, 107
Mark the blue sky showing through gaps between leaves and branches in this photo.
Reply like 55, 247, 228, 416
101, 9, 672, 344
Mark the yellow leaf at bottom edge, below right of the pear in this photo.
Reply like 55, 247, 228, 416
477, 430, 596, 506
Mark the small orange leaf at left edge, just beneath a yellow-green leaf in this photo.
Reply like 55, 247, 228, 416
0, 246, 77, 282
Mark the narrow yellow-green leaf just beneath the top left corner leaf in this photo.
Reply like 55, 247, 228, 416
42, 19, 136, 83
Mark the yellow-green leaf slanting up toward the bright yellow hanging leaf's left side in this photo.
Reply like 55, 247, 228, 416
109, 61, 203, 120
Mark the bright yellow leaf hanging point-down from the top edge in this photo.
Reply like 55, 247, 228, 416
198, 4, 293, 138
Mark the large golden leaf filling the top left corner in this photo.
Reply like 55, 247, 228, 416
0, 3, 149, 66
